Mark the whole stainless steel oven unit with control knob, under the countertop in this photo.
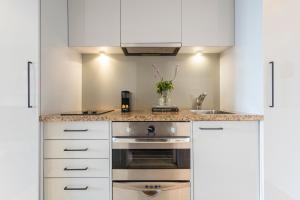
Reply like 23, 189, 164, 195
112, 122, 191, 200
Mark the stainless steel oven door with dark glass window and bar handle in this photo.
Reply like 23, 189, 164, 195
112, 138, 191, 181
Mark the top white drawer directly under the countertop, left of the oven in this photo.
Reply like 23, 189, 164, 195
44, 121, 109, 139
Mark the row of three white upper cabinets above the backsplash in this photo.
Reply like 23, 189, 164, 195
68, 0, 234, 47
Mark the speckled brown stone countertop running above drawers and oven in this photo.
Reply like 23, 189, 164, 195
40, 110, 263, 122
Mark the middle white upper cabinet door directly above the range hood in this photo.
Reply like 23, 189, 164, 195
121, 0, 181, 44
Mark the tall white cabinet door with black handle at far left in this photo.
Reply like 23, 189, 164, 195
0, 0, 39, 200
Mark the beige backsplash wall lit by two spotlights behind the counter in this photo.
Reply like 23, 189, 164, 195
83, 54, 220, 109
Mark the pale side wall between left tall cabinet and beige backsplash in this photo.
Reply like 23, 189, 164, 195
41, 0, 82, 114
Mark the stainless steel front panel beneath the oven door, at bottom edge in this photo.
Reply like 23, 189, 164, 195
113, 182, 190, 200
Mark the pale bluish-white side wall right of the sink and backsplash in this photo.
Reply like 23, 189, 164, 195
220, 0, 264, 113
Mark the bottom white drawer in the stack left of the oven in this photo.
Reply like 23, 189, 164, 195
44, 178, 109, 200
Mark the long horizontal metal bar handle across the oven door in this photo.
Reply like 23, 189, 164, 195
112, 137, 191, 144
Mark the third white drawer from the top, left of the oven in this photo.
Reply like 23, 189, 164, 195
44, 159, 109, 178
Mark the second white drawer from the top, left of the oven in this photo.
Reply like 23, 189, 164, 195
44, 140, 109, 158
